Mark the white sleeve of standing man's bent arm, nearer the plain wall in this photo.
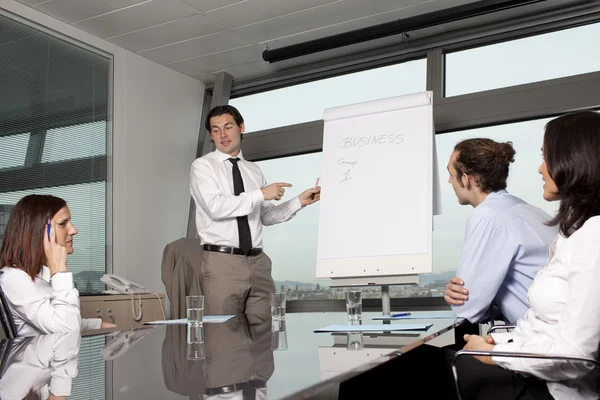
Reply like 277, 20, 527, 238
190, 159, 264, 221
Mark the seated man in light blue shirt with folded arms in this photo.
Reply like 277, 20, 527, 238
444, 139, 558, 323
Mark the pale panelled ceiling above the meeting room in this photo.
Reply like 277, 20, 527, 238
19, 0, 588, 84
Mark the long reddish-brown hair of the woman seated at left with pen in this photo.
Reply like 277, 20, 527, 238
0, 194, 67, 279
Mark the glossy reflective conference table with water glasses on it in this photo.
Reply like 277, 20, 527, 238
0, 312, 456, 400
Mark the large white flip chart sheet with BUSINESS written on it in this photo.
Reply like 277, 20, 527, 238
317, 106, 432, 259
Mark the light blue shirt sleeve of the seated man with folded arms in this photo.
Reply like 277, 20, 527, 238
452, 216, 516, 323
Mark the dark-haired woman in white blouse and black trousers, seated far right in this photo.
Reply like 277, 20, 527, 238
340, 111, 600, 400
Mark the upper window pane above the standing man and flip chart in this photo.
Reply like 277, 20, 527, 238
229, 60, 427, 132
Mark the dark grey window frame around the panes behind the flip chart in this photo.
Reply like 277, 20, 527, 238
190, 6, 600, 312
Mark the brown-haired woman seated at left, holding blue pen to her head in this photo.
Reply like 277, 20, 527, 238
0, 195, 116, 336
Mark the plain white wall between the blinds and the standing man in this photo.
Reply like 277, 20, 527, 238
0, 0, 205, 293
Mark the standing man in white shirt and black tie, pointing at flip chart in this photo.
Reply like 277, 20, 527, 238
190, 105, 321, 315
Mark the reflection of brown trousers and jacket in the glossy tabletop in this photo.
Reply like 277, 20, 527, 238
162, 315, 276, 400
